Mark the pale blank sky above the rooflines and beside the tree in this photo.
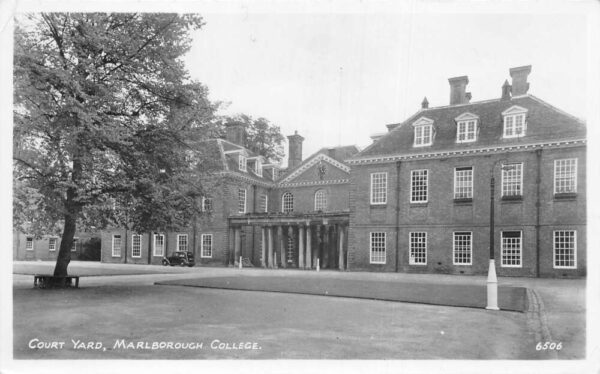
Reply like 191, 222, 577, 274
185, 12, 588, 164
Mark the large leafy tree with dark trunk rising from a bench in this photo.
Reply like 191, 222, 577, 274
13, 13, 215, 277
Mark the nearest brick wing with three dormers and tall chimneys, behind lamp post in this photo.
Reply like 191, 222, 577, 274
348, 66, 586, 277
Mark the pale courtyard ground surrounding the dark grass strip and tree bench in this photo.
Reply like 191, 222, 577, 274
13, 262, 585, 359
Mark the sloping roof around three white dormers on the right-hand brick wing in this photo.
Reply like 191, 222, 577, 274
353, 95, 586, 159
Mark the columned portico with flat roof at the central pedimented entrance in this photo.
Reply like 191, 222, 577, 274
227, 212, 349, 270
